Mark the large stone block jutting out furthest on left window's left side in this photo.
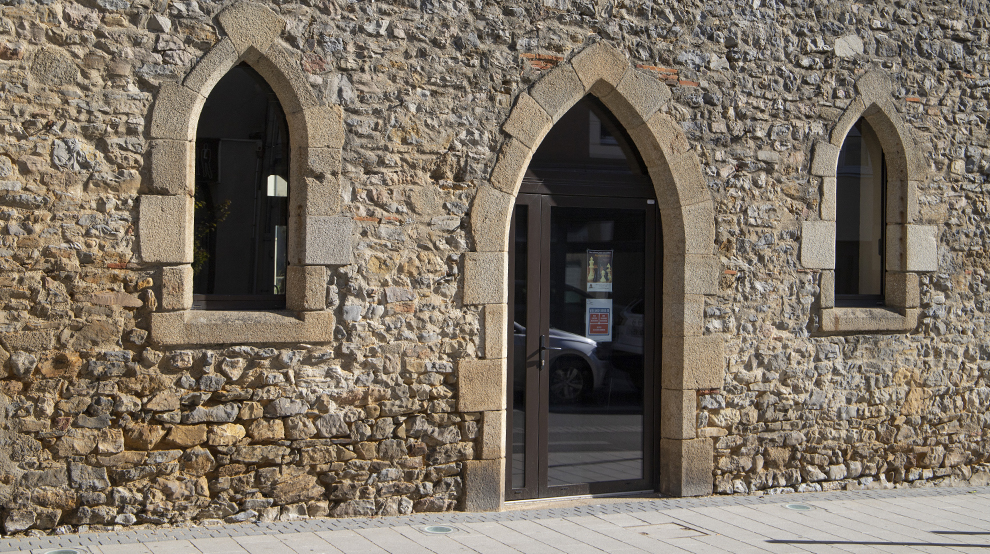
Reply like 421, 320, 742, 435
138, 196, 193, 264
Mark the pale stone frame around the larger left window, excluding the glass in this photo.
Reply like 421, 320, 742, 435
137, 2, 353, 344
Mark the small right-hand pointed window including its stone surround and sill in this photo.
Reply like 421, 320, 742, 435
801, 71, 938, 333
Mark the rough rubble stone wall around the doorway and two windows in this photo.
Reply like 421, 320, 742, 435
0, 0, 990, 533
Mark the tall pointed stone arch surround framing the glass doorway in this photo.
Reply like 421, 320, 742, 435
458, 43, 725, 510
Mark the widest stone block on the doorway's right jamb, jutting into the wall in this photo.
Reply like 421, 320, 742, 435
662, 335, 725, 390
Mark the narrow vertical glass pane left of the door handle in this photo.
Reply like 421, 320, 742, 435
512, 206, 529, 489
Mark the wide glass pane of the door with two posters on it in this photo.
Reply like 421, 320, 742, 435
548, 207, 646, 486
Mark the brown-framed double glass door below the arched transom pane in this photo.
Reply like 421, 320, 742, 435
506, 194, 659, 500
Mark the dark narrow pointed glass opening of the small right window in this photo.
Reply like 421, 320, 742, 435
835, 119, 887, 306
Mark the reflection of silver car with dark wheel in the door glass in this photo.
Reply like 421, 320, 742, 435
512, 322, 608, 404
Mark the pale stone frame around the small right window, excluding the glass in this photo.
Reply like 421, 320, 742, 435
801, 71, 938, 333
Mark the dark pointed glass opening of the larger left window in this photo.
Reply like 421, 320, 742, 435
193, 64, 290, 310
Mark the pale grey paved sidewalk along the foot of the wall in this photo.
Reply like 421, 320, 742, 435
0, 487, 990, 554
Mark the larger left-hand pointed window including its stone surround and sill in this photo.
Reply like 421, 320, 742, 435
136, 2, 353, 345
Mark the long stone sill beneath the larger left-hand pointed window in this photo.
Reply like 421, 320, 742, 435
151, 310, 336, 345
